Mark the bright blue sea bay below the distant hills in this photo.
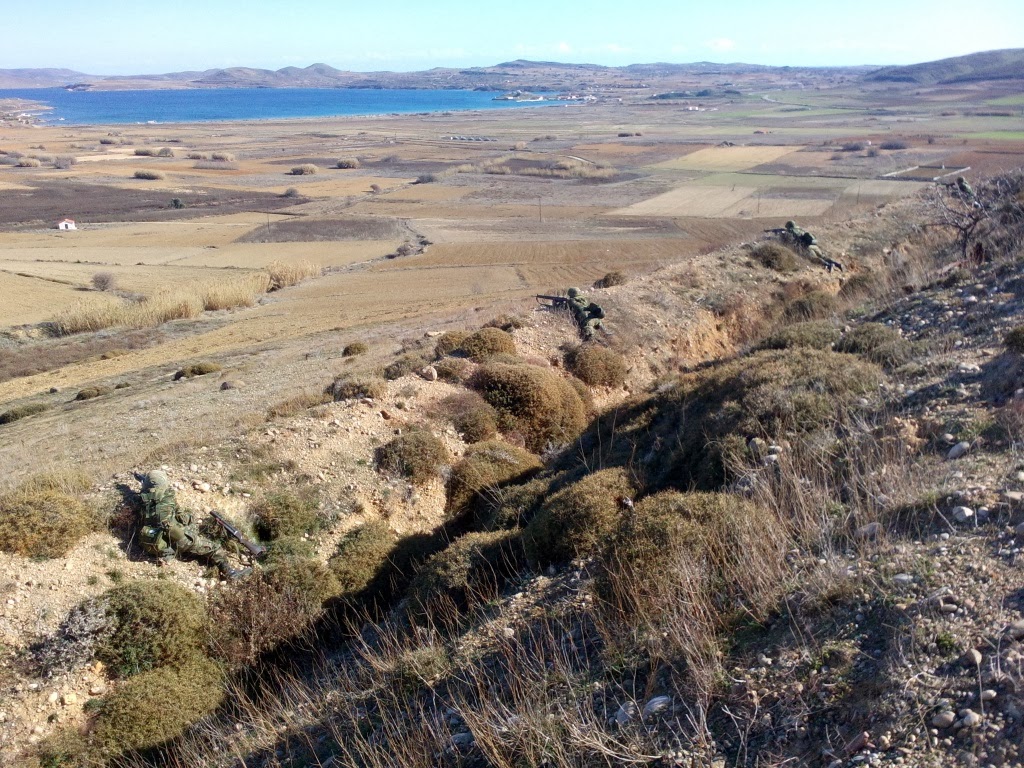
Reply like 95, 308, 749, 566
0, 88, 559, 125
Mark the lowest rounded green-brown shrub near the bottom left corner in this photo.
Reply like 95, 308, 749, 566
90, 658, 224, 758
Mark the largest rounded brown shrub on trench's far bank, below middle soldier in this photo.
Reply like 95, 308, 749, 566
471, 362, 587, 453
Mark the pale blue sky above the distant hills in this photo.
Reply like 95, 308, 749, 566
0, 0, 1024, 75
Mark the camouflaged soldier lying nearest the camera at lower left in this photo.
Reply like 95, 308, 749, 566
139, 469, 251, 581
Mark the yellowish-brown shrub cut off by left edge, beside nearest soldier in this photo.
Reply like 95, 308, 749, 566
0, 472, 105, 557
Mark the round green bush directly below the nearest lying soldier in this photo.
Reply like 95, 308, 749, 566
95, 581, 207, 677
